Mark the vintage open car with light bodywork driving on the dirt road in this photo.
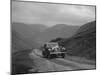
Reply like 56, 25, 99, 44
42, 42, 66, 58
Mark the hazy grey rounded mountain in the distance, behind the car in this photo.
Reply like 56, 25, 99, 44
36, 24, 79, 42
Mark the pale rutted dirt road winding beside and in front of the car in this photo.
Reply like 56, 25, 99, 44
30, 49, 95, 72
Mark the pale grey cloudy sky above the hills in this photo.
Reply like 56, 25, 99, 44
12, 1, 95, 26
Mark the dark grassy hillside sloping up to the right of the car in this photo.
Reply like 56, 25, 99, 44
52, 21, 96, 60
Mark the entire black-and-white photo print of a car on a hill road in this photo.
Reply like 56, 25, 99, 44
11, 0, 96, 75
